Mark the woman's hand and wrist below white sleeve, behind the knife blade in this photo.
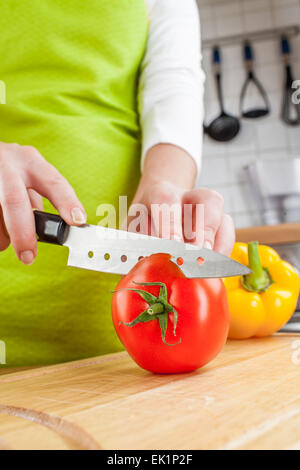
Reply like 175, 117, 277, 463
128, 145, 235, 256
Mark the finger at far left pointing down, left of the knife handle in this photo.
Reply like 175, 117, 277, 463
0, 167, 37, 265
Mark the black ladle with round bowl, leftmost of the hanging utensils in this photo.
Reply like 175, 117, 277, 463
204, 47, 240, 142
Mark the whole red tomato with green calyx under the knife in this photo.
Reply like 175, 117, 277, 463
112, 254, 229, 374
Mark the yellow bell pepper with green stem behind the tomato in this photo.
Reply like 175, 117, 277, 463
224, 242, 300, 339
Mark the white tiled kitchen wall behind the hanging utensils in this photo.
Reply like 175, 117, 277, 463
198, 0, 300, 227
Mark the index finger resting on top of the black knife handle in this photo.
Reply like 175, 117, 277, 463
22, 148, 87, 225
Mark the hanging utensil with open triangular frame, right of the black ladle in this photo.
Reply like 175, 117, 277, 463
240, 41, 270, 119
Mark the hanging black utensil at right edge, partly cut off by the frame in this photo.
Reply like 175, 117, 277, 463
281, 36, 300, 126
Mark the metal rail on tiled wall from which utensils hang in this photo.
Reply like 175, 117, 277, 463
202, 25, 300, 49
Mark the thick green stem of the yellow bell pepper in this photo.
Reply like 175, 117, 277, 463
242, 242, 273, 293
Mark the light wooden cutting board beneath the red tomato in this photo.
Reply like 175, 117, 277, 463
0, 334, 300, 449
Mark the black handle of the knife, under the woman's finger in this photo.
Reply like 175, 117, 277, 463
34, 211, 69, 245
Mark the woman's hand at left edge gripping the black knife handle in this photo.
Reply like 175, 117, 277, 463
0, 142, 86, 265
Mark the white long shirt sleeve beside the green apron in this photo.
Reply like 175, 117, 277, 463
139, 0, 205, 171
